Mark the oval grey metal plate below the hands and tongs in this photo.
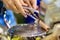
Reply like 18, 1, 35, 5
9, 24, 46, 37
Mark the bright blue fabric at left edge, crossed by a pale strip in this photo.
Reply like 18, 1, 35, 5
0, 10, 16, 27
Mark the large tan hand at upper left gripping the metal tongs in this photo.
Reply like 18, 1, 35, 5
3, 0, 27, 17
